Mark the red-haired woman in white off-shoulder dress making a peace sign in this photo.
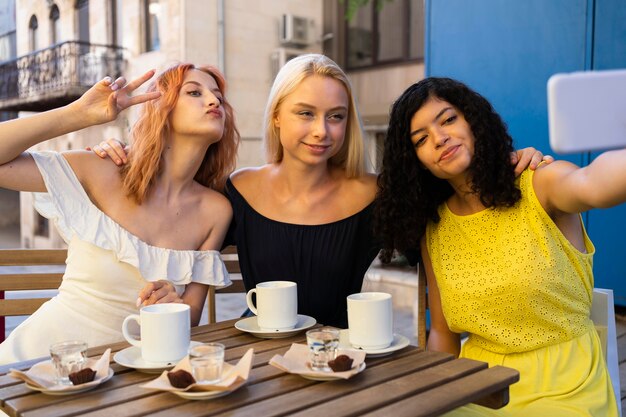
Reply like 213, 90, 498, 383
0, 64, 239, 363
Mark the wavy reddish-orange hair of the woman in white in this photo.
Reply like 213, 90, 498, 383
121, 64, 240, 204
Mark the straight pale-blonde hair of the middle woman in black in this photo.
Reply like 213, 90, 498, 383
263, 54, 365, 178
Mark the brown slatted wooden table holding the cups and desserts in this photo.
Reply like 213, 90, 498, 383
0, 320, 519, 417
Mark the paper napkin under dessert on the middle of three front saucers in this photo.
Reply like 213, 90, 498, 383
140, 348, 254, 392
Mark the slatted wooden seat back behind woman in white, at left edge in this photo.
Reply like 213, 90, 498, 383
0, 249, 67, 342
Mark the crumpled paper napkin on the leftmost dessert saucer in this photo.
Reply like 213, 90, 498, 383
9, 349, 111, 391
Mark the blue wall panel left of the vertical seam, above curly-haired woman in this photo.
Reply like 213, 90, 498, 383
426, 0, 589, 164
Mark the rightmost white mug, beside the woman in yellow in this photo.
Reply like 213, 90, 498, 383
348, 292, 393, 350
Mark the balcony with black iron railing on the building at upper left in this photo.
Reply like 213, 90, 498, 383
0, 41, 125, 111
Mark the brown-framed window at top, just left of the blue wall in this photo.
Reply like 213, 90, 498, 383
344, 0, 424, 69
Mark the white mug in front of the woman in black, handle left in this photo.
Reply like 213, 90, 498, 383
246, 281, 298, 330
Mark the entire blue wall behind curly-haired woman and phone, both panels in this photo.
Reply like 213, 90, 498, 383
425, 0, 626, 305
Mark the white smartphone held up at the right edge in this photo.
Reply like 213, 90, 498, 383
548, 69, 626, 153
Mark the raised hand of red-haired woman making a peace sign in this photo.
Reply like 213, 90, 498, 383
71, 70, 161, 125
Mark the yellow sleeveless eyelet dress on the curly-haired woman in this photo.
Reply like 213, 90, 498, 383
426, 170, 618, 417
